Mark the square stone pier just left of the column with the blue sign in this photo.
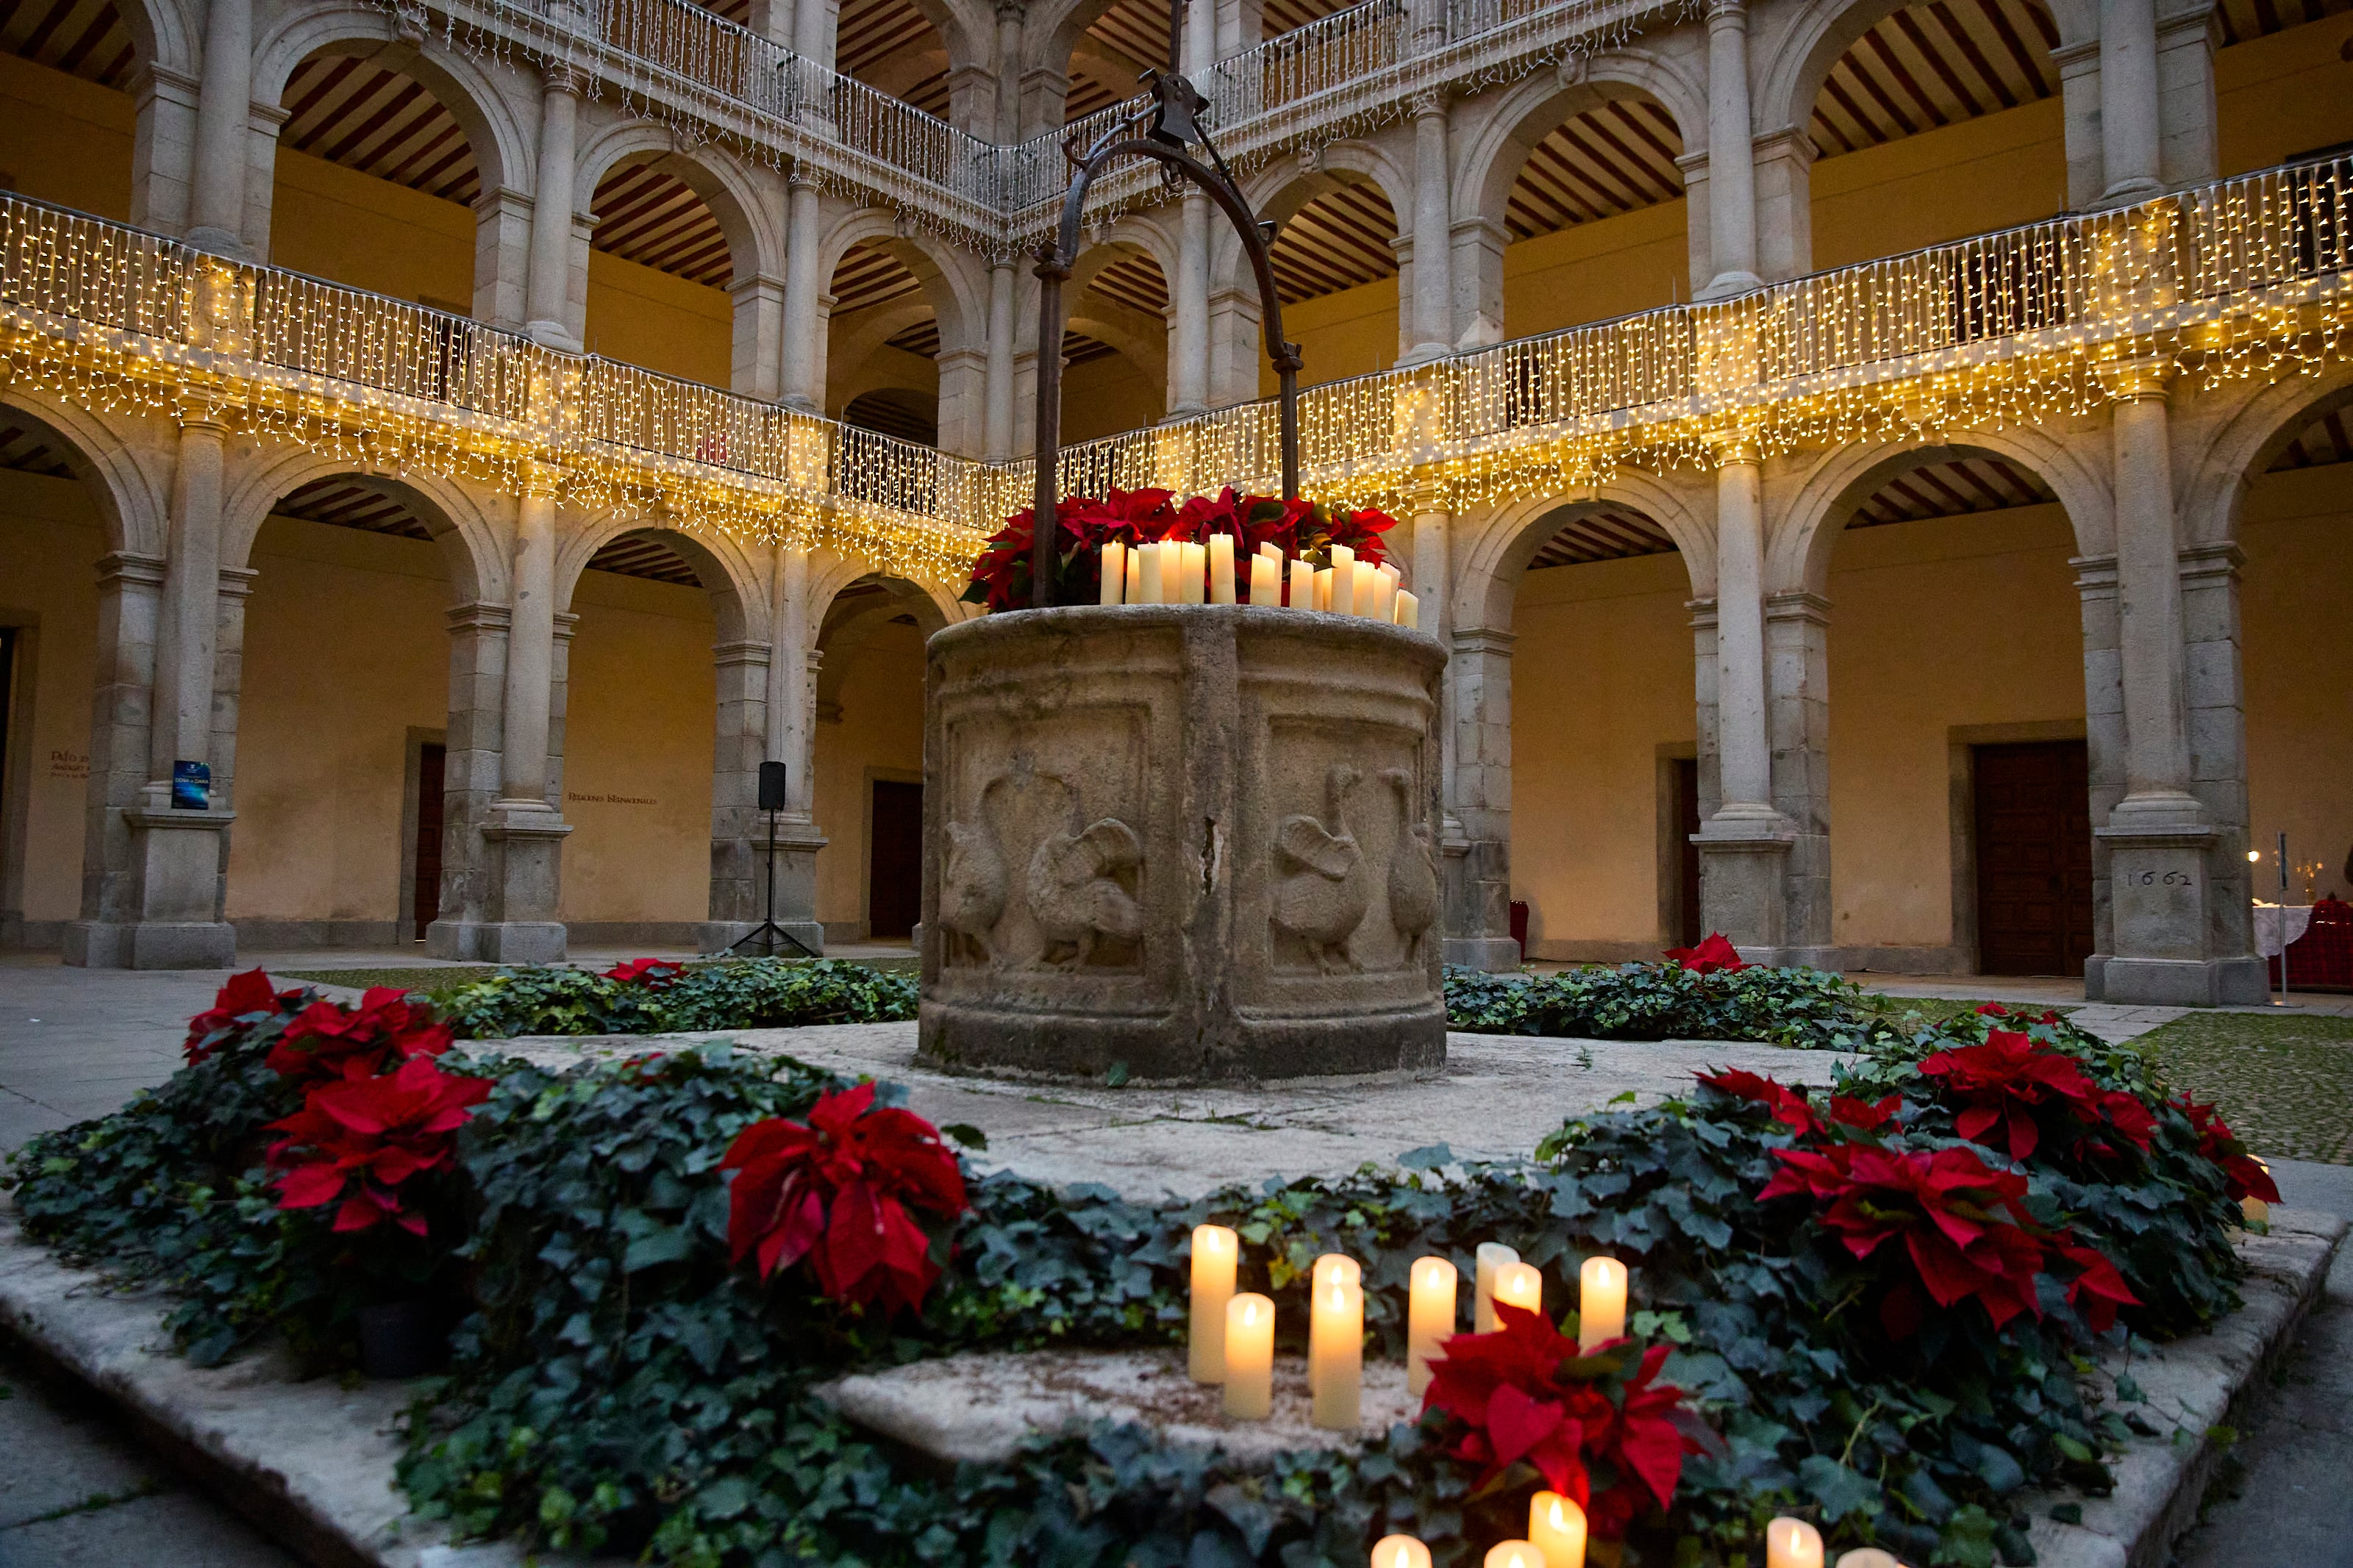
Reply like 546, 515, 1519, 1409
63, 553, 165, 969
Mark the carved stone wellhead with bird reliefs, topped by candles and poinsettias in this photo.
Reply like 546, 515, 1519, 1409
920, 604, 1445, 1084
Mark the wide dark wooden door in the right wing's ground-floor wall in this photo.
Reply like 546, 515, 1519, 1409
1977, 740, 2092, 975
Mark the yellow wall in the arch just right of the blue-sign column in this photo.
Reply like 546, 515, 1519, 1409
228, 518, 454, 922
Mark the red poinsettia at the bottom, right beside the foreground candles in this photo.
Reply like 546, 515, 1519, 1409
1421, 1303, 1702, 1540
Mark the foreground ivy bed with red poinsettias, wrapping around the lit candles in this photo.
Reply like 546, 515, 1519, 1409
10, 966, 2261, 1568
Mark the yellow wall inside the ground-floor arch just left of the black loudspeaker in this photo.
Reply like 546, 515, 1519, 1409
563, 571, 718, 922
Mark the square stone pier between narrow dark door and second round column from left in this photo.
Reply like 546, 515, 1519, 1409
426, 602, 508, 959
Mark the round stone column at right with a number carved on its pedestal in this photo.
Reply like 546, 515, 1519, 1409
2085, 362, 2266, 1004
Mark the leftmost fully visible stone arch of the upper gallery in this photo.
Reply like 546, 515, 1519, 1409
254, 4, 539, 190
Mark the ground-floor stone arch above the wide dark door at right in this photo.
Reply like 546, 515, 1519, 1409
1765, 428, 2115, 593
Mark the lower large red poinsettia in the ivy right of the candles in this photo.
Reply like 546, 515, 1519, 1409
1757, 1142, 2043, 1340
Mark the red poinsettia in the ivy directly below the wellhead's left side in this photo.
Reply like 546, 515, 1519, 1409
720, 1084, 965, 1311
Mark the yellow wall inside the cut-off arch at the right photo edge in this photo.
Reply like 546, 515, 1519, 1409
2240, 468, 2353, 901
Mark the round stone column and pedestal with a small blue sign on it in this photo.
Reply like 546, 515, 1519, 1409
118, 418, 238, 969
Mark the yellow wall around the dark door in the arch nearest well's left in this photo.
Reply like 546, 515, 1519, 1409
814, 620, 922, 928
